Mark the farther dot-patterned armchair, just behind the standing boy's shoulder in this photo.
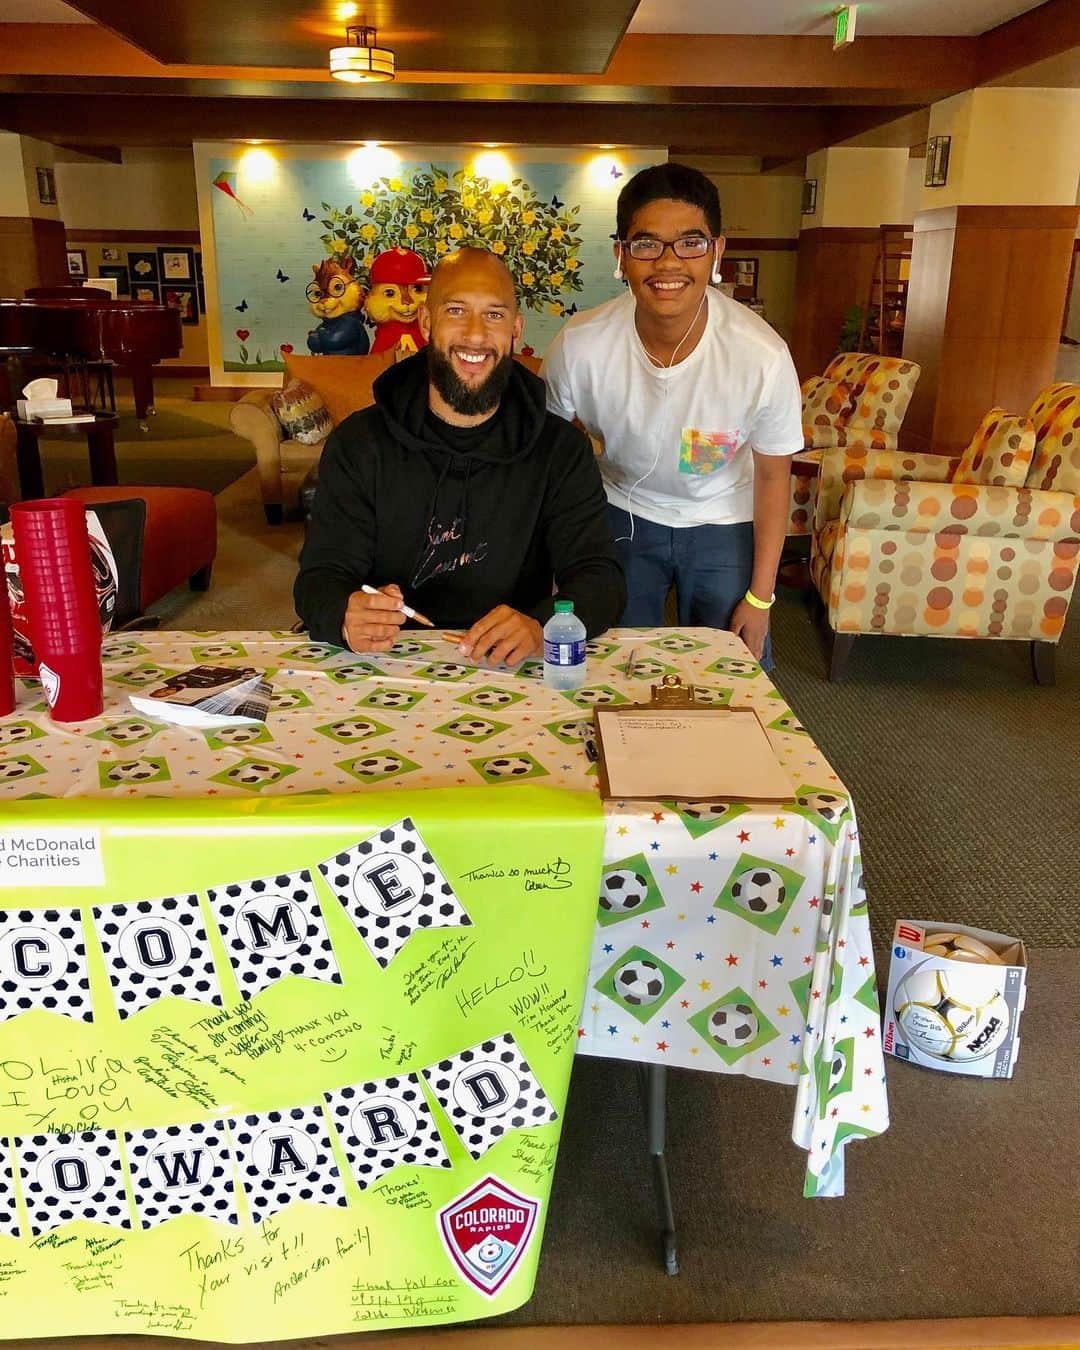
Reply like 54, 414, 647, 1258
787, 351, 922, 535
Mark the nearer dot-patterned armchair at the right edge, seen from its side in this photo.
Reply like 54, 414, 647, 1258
810, 383, 1080, 684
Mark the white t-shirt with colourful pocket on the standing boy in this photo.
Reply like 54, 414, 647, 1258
541, 286, 803, 527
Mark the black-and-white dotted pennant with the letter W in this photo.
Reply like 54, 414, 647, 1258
124, 1121, 239, 1229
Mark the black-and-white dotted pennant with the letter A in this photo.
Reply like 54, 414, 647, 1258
228, 1106, 348, 1223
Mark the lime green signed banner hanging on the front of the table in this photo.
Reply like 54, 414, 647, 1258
0, 786, 603, 1342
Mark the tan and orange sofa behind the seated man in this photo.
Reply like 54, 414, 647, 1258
230, 351, 540, 525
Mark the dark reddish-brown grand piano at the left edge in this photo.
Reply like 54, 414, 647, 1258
0, 286, 182, 431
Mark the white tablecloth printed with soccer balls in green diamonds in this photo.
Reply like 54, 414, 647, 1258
0, 629, 888, 1195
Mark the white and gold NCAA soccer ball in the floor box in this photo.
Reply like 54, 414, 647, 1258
892, 963, 1008, 1064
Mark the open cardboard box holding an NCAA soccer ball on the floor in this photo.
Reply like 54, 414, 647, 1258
883, 919, 1027, 1079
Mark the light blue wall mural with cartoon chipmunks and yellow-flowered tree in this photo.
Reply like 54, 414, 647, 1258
200, 147, 660, 382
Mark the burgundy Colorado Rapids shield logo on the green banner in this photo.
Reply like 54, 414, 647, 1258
439, 1177, 540, 1299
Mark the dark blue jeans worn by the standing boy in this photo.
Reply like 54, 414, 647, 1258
608, 502, 774, 671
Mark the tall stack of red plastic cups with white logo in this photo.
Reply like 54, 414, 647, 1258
11, 497, 103, 722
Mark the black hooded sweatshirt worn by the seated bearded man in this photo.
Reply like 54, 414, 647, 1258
294, 351, 626, 644
